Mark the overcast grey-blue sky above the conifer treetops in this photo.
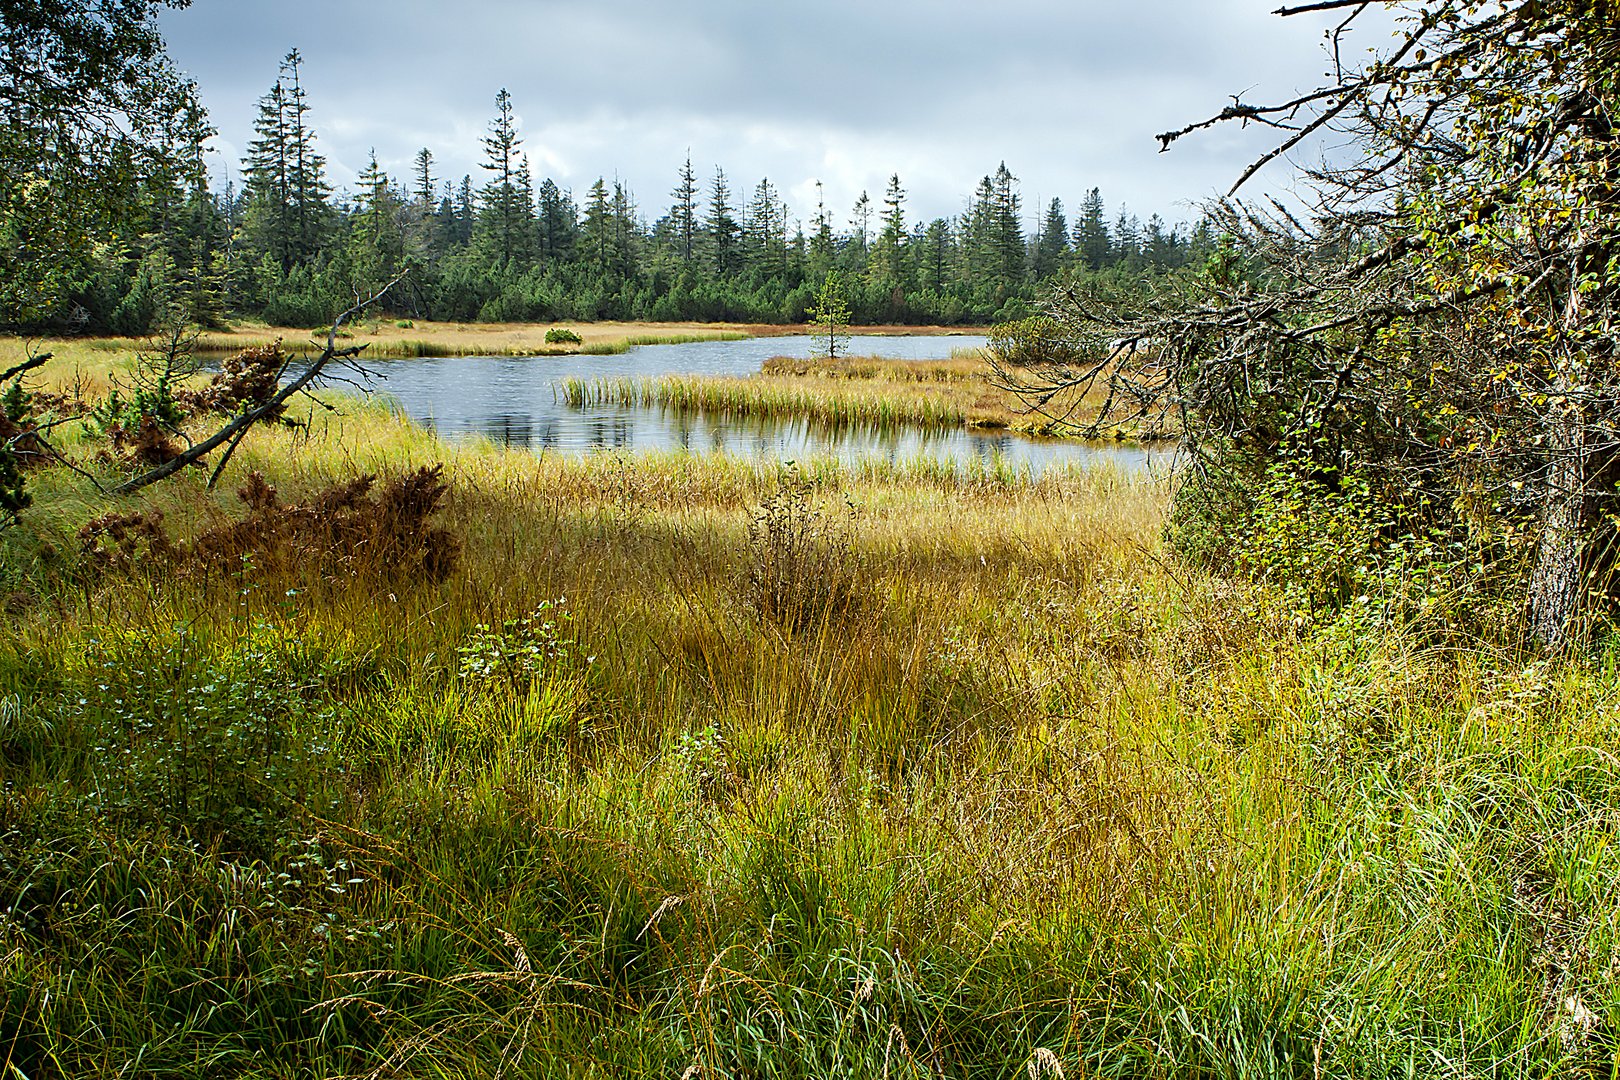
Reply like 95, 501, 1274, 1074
162, 0, 1387, 227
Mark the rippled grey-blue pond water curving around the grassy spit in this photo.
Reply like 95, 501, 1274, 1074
312, 335, 1165, 474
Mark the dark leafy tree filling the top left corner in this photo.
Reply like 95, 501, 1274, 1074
0, 0, 212, 327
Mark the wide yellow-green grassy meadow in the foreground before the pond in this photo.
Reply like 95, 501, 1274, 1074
0, 399, 1620, 1078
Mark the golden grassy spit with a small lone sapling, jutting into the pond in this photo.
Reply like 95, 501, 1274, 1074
562, 353, 1094, 436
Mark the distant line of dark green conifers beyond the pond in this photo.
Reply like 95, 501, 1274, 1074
0, 50, 1213, 335
